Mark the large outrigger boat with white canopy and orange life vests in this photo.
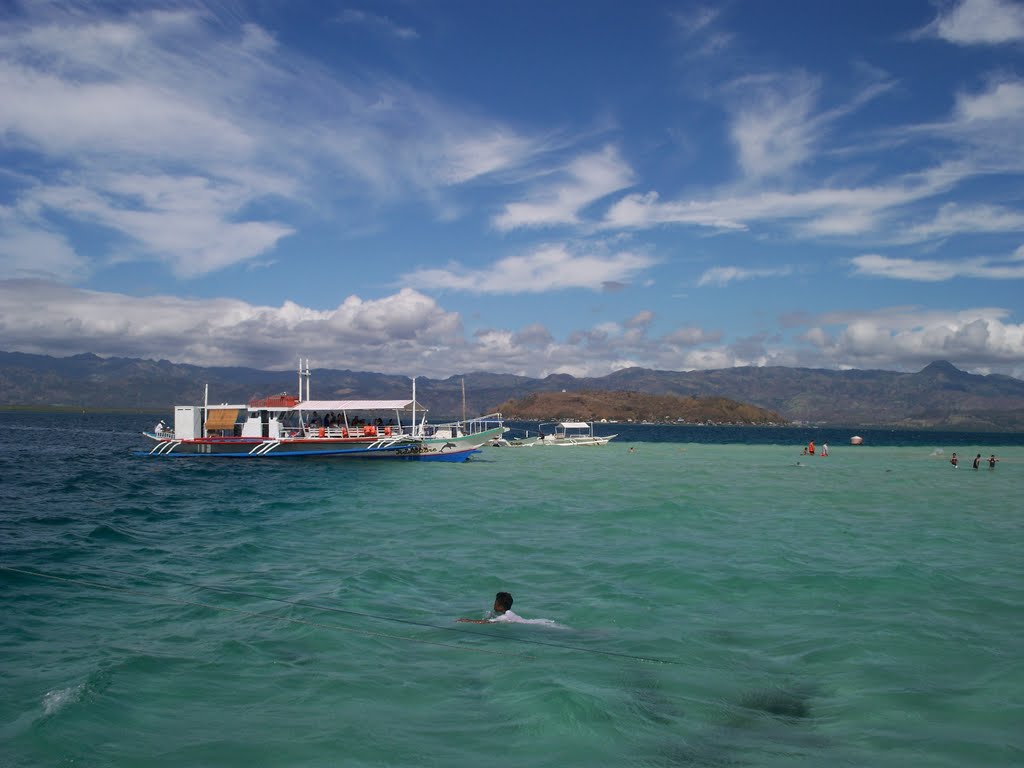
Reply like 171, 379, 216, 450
142, 364, 505, 462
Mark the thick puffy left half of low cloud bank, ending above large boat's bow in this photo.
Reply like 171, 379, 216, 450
0, 281, 463, 373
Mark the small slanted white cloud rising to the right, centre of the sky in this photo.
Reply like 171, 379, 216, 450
495, 146, 633, 231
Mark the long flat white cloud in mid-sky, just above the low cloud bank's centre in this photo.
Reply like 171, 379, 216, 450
401, 244, 656, 294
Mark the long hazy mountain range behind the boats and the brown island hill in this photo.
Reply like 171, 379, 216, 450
6, 352, 1024, 431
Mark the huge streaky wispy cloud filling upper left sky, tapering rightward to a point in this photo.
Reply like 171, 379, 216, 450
0, 5, 540, 279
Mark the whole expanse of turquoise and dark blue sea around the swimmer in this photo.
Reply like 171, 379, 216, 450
0, 414, 1024, 767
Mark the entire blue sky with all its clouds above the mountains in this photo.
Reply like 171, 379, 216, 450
0, 0, 1024, 378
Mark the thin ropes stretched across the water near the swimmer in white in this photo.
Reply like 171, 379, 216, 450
6, 564, 681, 665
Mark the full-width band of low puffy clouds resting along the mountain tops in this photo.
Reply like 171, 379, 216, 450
0, 280, 1024, 378
